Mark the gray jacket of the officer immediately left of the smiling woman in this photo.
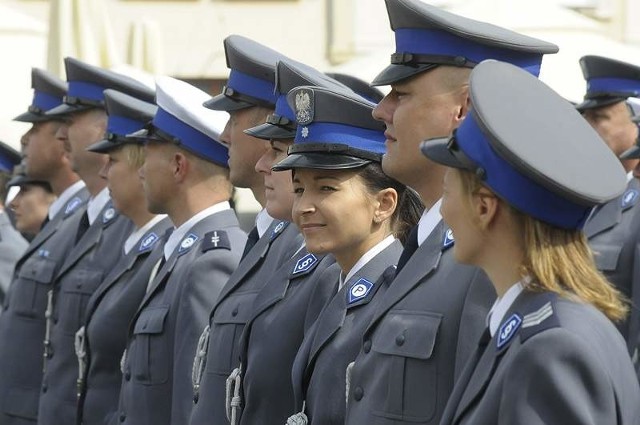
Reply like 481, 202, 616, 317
239, 248, 340, 425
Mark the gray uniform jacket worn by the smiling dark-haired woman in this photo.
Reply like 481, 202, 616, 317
291, 240, 402, 425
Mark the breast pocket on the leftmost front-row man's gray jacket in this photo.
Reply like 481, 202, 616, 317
8, 257, 56, 318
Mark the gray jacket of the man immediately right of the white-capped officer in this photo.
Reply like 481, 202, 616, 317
189, 221, 302, 425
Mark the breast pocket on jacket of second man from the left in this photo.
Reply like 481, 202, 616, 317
55, 268, 102, 335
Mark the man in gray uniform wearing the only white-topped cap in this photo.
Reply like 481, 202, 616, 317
113, 77, 246, 425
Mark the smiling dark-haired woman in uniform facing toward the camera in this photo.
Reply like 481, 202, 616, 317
273, 87, 422, 424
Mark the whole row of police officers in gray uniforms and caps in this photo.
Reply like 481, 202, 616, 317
0, 0, 640, 425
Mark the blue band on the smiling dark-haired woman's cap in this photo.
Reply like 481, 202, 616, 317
294, 122, 386, 154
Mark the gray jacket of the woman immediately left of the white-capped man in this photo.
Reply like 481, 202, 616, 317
76, 217, 173, 425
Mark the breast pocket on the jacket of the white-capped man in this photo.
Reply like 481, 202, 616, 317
128, 306, 171, 385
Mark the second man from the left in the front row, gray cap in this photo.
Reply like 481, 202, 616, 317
38, 58, 154, 425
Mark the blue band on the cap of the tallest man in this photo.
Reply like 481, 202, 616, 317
395, 28, 542, 77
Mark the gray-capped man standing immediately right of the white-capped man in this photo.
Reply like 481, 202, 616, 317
189, 35, 302, 424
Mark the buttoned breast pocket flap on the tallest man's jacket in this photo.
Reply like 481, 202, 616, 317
371, 310, 442, 359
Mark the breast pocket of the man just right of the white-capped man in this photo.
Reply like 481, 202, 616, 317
206, 292, 257, 376
